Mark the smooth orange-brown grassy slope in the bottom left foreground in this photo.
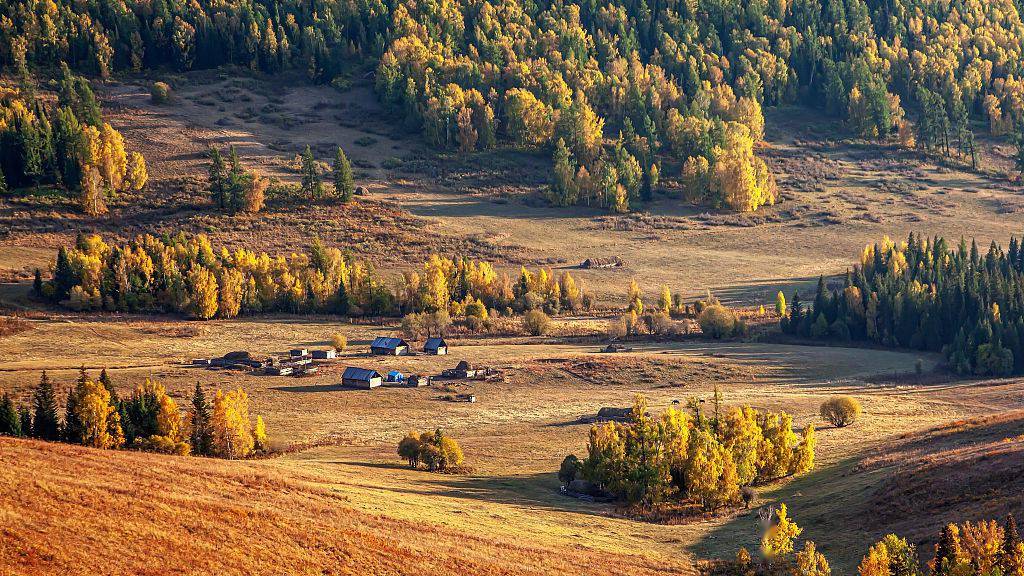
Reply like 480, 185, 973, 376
0, 439, 688, 575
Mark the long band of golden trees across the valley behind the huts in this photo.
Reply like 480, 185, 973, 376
36, 231, 592, 321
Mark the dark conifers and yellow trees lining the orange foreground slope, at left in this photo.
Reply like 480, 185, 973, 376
0, 369, 268, 458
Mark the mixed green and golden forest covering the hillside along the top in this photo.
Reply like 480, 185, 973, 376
0, 0, 1024, 211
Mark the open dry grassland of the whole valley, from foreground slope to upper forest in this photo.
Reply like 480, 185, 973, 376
0, 72, 1024, 576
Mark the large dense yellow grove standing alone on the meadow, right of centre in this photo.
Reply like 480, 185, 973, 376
562, 394, 817, 509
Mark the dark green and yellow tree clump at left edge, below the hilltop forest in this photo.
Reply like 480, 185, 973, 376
0, 67, 148, 215
